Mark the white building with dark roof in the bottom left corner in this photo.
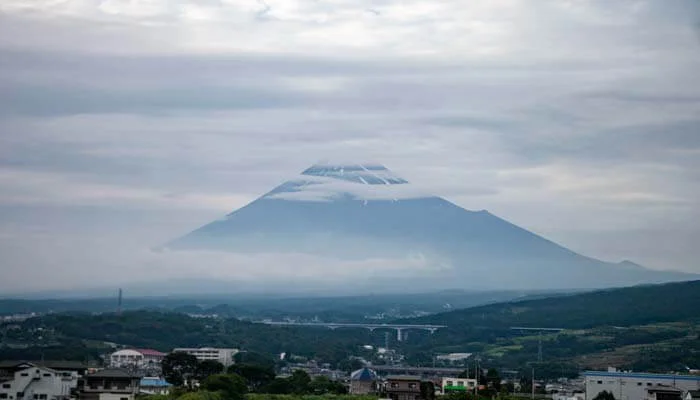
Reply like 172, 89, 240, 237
0, 365, 77, 400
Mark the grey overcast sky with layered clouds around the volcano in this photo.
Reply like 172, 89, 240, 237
0, 0, 700, 293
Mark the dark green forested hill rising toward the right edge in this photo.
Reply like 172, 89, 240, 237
404, 281, 700, 329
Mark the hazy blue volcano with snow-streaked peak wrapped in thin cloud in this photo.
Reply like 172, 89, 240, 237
165, 164, 693, 290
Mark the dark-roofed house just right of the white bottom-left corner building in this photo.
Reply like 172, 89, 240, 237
79, 368, 141, 400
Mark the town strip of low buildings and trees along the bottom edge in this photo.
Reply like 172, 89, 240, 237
0, 345, 700, 400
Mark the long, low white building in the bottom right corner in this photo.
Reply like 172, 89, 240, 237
583, 370, 700, 400
